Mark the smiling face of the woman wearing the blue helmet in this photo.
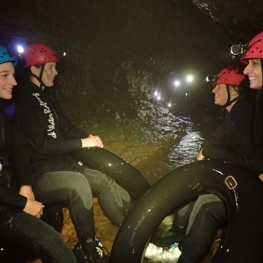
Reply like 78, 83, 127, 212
0, 62, 17, 100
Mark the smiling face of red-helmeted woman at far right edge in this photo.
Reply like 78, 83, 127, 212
244, 59, 263, 89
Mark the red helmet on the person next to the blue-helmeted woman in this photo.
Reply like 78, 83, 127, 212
22, 43, 58, 68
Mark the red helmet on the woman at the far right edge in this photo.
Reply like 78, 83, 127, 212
240, 31, 263, 64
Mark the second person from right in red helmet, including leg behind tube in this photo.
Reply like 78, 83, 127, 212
171, 65, 260, 263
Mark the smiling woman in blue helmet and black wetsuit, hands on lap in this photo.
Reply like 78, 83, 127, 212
0, 44, 77, 263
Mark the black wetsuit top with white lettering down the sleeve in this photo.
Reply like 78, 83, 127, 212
15, 82, 88, 178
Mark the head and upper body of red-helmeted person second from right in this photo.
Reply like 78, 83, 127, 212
197, 66, 254, 166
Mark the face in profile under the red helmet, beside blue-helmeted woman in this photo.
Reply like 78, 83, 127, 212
31, 62, 58, 87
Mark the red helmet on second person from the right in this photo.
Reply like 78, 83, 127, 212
213, 65, 246, 86
